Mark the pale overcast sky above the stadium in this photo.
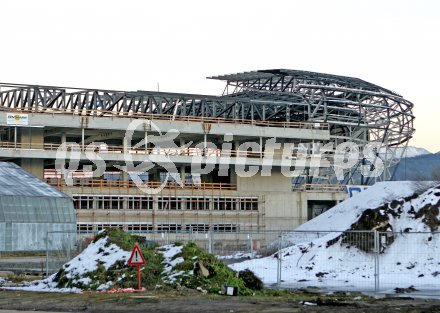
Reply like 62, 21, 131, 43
0, 0, 440, 152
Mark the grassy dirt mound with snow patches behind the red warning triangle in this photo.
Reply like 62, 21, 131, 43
9, 228, 258, 295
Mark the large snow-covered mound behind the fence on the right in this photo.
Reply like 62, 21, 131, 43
230, 182, 440, 289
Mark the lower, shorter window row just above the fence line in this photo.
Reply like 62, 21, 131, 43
76, 223, 237, 234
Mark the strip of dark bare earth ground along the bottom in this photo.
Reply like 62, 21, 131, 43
0, 290, 440, 313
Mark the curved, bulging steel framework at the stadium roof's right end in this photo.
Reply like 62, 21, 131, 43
209, 69, 415, 183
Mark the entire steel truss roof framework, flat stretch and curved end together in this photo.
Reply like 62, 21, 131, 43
0, 69, 415, 183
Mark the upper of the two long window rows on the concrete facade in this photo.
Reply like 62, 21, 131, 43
74, 195, 258, 211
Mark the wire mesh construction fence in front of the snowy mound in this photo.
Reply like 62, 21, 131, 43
46, 230, 440, 295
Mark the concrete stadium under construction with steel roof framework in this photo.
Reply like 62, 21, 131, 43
0, 69, 414, 238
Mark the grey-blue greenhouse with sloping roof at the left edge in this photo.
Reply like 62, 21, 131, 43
0, 162, 76, 252
